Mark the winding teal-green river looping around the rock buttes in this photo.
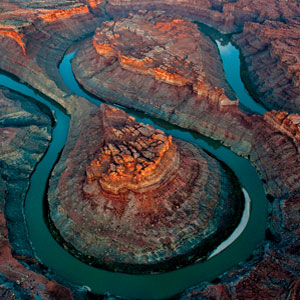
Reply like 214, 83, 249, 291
0, 27, 267, 299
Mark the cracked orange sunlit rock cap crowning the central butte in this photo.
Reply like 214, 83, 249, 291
85, 106, 178, 193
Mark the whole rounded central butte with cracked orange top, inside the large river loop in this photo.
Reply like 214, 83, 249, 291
48, 104, 243, 272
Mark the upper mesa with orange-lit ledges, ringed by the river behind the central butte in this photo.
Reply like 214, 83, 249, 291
73, 12, 238, 113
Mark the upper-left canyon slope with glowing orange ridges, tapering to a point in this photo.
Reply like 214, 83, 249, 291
0, 0, 103, 111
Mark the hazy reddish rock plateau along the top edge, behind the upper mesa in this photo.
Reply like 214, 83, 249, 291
106, 0, 300, 33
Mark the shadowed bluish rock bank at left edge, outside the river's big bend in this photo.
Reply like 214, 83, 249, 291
0, 88, 72, 299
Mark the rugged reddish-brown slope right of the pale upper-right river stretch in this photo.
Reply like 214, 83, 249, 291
234, 20, 300, 112
